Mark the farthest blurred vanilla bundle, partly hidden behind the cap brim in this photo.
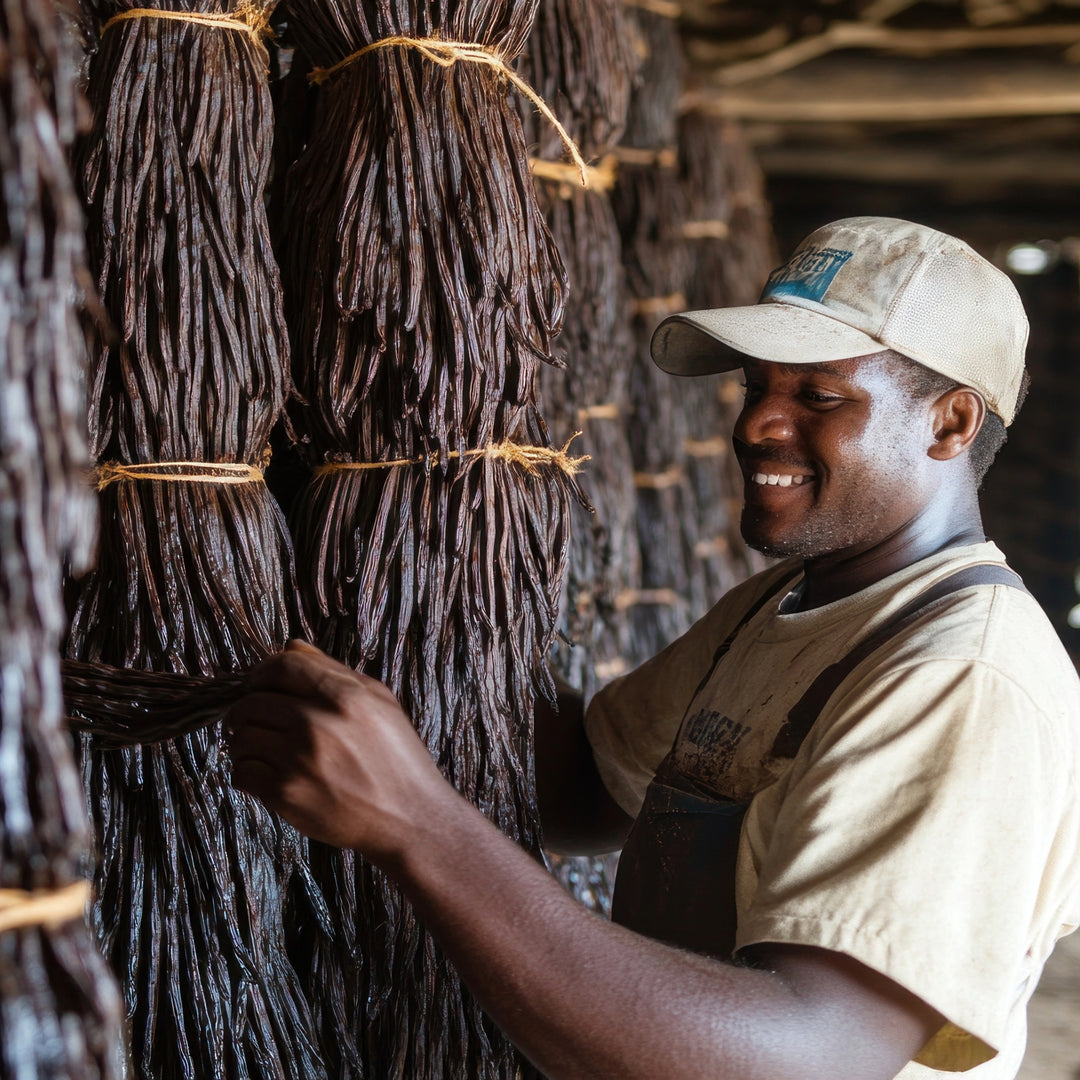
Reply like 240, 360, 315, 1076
678, 112, 773, 611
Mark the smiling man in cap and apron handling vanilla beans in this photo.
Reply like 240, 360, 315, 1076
230, 218, 1080, 1080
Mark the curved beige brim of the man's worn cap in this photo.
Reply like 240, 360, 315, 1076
651, 302, 887, 375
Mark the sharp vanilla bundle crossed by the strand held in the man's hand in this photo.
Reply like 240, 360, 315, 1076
68, 3, 327, 1080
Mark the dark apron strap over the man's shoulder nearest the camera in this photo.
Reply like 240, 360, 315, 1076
772, 563, 1030, 757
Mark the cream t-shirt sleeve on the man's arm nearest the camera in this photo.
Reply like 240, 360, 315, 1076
738, 660, 1075, 1070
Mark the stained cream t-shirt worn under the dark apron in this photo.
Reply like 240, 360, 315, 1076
585, 543, 1080, 1080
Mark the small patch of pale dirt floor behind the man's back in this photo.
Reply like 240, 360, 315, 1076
1017, 933, 1080, 1080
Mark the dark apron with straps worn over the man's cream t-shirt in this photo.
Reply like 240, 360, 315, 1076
611, 564, 1024, 959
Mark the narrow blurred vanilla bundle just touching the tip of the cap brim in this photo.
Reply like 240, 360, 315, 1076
612, 8, 694, 663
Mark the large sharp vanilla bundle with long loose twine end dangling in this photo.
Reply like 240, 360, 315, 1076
279, 0, 576, 1080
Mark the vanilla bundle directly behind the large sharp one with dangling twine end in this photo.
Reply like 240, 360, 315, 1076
518, 0, 638, 696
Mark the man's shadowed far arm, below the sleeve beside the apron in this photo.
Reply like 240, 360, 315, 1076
536, 678, 633, 855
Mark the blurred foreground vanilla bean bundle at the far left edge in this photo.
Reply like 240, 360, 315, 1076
0, 0, 124, 1067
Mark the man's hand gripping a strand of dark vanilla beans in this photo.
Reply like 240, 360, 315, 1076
226, 640, 455, 863
